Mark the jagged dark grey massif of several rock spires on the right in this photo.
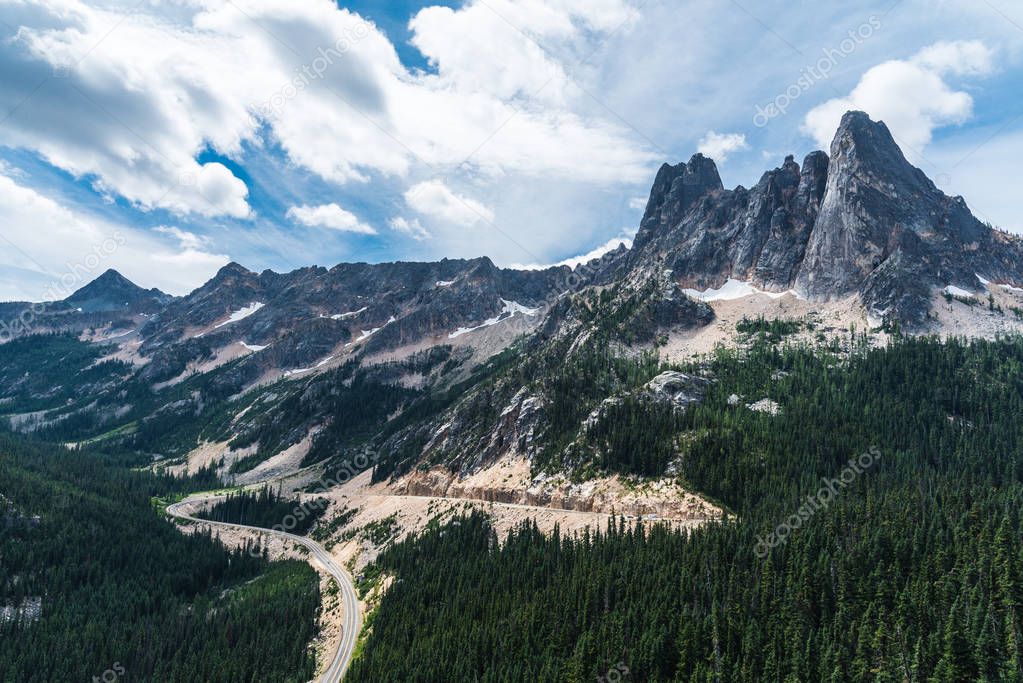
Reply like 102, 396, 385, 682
625, 111, 1023, 328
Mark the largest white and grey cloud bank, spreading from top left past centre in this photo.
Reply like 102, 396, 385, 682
0, 0, 652, 218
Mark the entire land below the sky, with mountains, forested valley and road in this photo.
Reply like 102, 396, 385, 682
6, 111, 1023, 682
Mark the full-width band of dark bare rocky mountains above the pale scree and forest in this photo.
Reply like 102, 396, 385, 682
6, 111, 1023, 355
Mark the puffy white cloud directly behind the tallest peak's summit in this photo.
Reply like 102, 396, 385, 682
803, 41, 993, 161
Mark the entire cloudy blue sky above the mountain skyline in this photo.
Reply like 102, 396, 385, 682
0, 0, 1023, 300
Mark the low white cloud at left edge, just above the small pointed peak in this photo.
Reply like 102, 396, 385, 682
0, 167, 230, 301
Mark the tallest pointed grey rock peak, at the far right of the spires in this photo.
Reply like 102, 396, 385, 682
795, 111, 1023, 325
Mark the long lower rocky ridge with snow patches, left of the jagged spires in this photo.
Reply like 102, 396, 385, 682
128, 258, 572, 384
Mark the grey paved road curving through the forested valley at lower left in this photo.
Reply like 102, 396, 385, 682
167, 496, 362, 683
